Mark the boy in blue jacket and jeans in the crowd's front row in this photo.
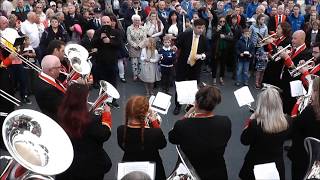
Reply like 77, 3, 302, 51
235, 28, 255, 86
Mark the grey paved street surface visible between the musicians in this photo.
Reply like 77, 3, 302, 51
0, 70, 290, 180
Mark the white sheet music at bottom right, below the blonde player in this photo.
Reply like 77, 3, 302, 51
253, 162, 280, 180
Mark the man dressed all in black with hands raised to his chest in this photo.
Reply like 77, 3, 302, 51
92, 16, 121, 108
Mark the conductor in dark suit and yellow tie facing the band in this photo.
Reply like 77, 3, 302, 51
173, 19, 207, 115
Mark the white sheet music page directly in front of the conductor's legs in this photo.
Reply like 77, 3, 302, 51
175, 80, 198, 104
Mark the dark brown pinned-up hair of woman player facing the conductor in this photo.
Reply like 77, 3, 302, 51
196, 85, 221, 111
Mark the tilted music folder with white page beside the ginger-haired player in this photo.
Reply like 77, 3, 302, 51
149, 92, 171, 114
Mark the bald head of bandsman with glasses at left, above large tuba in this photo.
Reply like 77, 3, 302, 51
41, 55, 61, 79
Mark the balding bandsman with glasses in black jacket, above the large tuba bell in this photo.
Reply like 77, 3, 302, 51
35, 55, 65, 121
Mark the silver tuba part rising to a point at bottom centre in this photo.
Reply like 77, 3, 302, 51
167, 145, 200, 180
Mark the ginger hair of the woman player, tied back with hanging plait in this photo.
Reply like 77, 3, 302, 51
122, 96, 149, 149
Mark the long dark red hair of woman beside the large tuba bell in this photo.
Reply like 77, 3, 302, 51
58, 83, 91, 138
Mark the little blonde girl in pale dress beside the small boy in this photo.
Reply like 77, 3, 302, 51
139, 38, 161, 96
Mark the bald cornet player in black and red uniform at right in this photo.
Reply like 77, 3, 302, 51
280, 30, 312, 114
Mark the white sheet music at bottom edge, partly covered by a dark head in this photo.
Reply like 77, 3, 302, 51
117, 161, 155, 180
